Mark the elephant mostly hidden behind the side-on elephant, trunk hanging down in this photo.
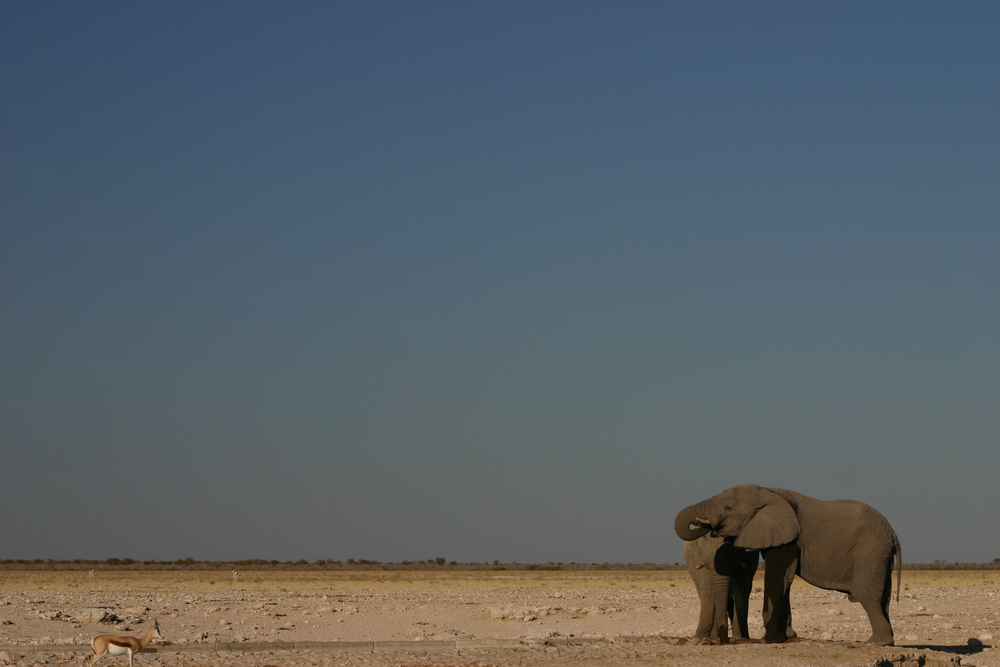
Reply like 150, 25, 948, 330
684, 534, 760, 644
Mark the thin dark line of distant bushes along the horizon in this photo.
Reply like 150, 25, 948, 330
0, 558, 1000, 572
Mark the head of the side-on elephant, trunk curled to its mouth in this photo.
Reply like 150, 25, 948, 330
674, 484, 801, 549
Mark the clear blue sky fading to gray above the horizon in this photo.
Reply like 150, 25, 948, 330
0, 0, 1000, 563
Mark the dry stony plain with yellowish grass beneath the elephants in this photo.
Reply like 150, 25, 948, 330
0, 570, 1000, 667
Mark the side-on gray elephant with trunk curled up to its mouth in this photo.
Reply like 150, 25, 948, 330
674, 484, 902, 646
